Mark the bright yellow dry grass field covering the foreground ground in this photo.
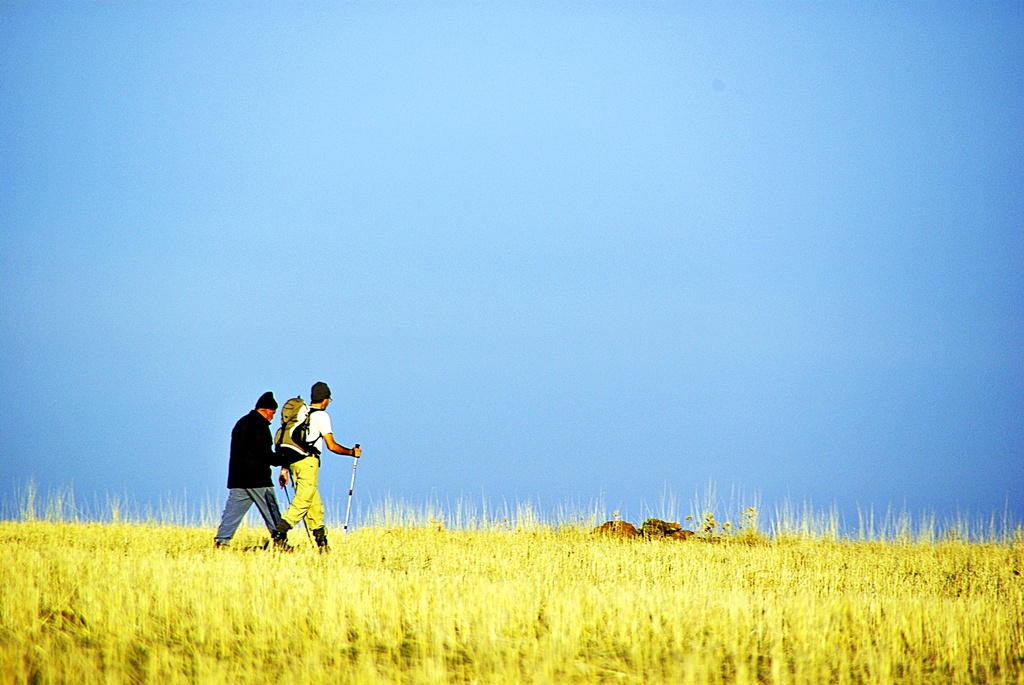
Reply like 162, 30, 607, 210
0, 511, 1024, 684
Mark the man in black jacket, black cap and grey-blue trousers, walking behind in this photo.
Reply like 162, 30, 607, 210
214, 392, 281, 547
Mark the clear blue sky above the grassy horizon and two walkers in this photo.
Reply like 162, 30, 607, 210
0, 2, 1024, 519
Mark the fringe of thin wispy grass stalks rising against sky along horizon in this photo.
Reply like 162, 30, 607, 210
0, 480, 1024, 544
